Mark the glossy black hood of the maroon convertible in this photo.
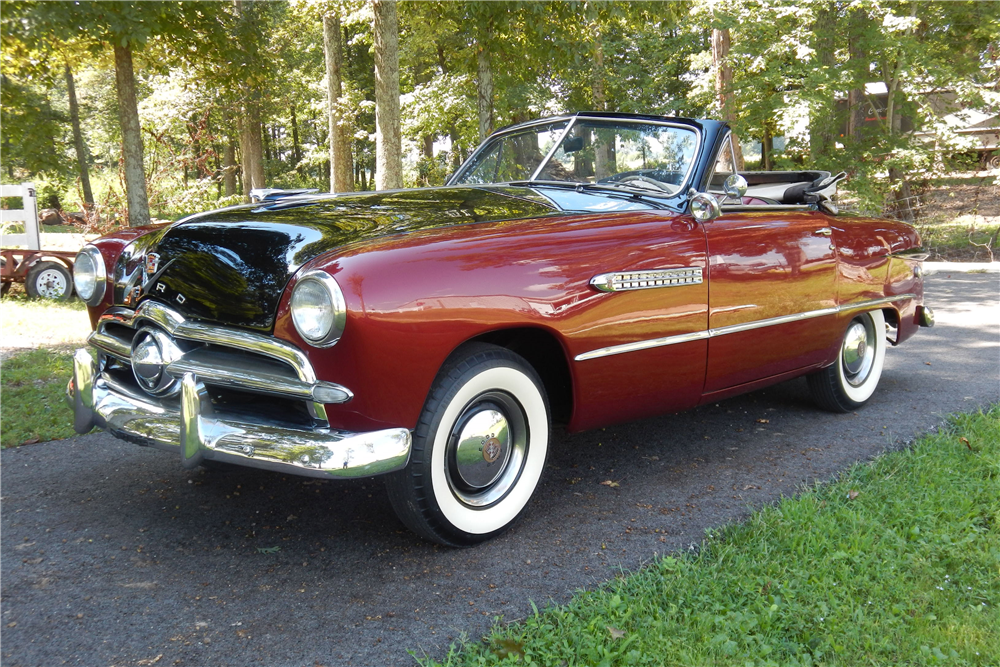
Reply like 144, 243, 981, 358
115, 186, 560, 331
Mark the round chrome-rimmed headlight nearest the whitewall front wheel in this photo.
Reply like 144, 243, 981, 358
291, 271, 347, 347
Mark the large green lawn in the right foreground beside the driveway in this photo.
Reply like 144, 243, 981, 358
425, 406, 1000, 666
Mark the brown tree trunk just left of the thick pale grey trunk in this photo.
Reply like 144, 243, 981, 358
323, 14, 356, 192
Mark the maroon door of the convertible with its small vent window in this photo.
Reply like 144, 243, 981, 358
703, 142, 840, 394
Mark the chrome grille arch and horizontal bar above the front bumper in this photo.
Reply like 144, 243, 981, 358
87, 301, 354, 421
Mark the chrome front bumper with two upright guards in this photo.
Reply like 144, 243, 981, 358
66, 349, 410, 478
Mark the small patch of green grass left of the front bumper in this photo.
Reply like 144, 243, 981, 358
0, 350, 75, 449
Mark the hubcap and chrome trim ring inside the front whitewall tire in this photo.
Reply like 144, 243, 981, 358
445, 392, 528, 508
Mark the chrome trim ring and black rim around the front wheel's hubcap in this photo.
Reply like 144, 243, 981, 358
445, 391, 531, 509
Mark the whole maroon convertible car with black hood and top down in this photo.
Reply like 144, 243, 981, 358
68, 113, 933, 546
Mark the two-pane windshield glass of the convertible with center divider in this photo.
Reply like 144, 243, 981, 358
455, 119, 698, 194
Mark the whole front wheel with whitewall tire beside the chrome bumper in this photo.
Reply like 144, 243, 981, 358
386, 344, 549, 546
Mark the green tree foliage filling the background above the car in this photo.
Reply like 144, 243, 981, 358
0, 0, 1000, 216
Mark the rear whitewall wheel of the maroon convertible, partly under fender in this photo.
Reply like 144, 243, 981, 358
806, 310, 886, 412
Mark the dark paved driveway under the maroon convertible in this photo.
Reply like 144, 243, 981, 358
0, 273, 1000, 667
